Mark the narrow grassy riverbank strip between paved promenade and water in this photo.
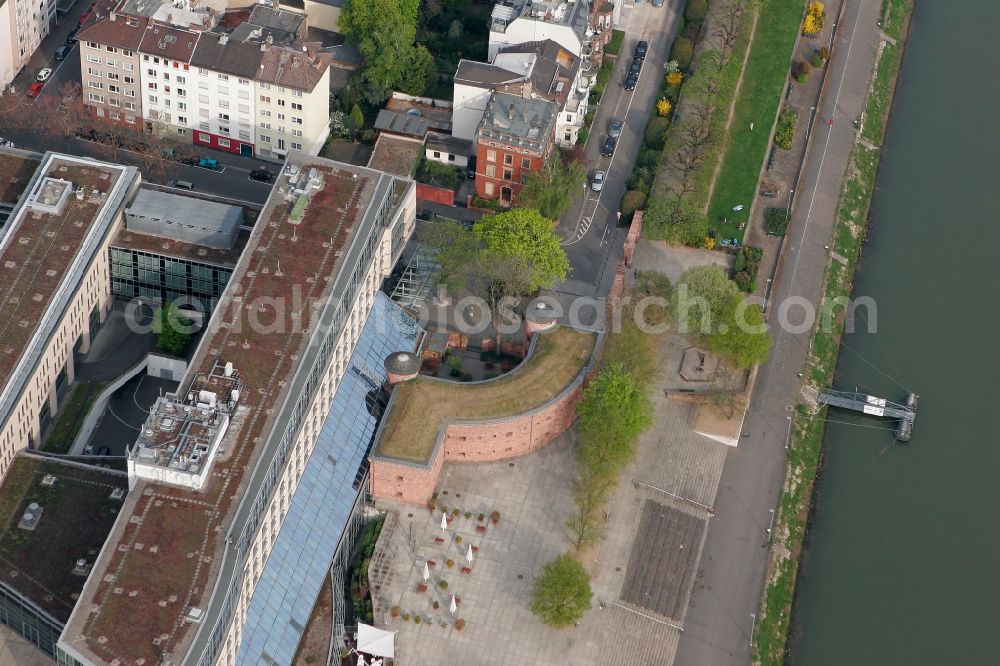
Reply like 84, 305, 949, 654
753, 0, 912, 665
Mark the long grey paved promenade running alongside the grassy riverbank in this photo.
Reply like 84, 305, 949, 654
674, 0, 879, 666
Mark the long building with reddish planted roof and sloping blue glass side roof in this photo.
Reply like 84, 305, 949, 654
57, 153, 418, 666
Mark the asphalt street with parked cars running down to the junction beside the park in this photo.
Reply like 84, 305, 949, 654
555, 0, 683, 297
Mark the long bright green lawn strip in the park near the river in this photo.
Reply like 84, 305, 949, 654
708, 0, 803, 239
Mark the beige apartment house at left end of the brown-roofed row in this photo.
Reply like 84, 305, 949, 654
77, 14, 148, 127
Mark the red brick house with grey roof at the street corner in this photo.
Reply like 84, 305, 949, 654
476, 92, 559, 205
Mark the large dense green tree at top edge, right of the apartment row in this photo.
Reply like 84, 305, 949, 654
339, 0, 420, 103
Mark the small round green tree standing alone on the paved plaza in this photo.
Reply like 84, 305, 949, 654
531, 553, 594, 629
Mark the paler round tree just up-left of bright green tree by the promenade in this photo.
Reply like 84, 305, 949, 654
670, 266, 742, 338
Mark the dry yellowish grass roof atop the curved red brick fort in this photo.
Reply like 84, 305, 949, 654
376, 328, 596, 462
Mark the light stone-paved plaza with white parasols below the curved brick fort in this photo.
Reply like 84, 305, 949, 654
376, 330, 727, 666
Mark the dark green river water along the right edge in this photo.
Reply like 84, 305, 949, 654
789, 0, 1000, 666
